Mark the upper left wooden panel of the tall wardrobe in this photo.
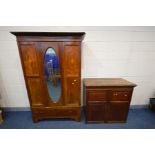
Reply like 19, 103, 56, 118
20, 44, 39, 76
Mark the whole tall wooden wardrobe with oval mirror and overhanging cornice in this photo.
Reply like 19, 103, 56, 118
11, 32, 85, 122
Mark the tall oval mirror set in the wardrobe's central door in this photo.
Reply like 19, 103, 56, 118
44, 48, 61, 103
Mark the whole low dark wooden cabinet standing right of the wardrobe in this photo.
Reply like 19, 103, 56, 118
84, 78, 136, 123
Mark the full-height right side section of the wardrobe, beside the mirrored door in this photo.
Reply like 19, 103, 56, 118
63, 42, 81, 106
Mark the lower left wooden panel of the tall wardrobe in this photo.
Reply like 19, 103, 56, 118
27, 78, 43, 106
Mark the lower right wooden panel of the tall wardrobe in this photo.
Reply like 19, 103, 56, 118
66, 77, 80, 105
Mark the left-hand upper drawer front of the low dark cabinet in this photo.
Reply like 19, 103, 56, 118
87, 90, 107, 101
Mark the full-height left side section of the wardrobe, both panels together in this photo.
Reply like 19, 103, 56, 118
18, 42, 43, 107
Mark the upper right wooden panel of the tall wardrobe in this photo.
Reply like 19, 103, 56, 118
64, 43, 81, 76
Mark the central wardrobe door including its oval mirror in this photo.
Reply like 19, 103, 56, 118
37, 42, 64, 107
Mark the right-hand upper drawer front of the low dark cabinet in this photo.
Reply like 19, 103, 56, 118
110, 90, 132, 101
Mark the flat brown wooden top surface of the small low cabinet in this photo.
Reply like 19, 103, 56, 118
83, 78, 136, 87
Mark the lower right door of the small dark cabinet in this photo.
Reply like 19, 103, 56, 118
105, 101, 129, 122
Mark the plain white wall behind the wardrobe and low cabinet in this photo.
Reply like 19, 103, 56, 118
0, 26, 155, 107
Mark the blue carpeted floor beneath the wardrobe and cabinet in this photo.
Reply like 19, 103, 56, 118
0, 108, 155, 129
